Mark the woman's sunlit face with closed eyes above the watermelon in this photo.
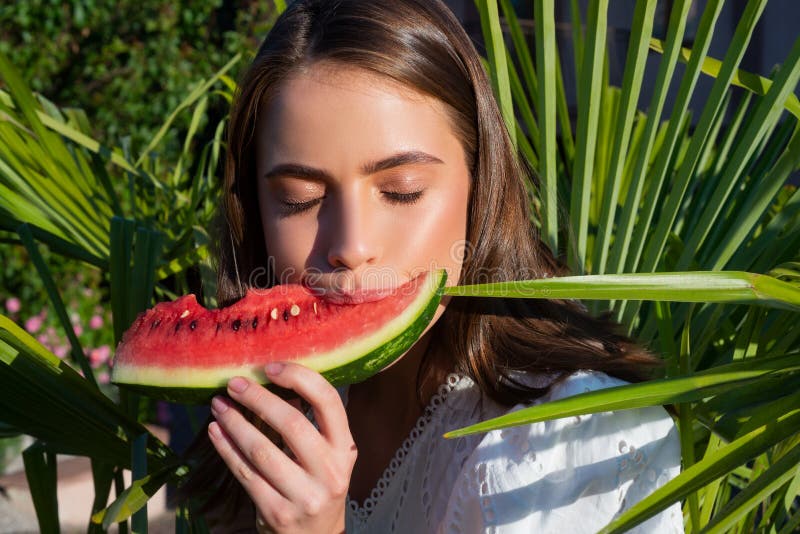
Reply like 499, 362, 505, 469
256, 64, 470, 318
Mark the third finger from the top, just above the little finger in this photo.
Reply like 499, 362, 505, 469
209, 397, 316, 501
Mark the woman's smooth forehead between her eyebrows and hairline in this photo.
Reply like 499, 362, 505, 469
258, 64, 460, 168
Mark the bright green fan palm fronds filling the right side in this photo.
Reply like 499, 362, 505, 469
472, 0, 800, 532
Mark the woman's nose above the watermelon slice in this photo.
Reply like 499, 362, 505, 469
328, 192, 381, 271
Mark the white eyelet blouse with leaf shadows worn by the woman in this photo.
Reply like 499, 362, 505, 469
342, 371, 683, 534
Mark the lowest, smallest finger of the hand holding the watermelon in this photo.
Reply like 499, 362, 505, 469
208, 421, 289, 509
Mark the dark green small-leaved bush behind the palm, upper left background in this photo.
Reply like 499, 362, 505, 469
0, 0, 274, 161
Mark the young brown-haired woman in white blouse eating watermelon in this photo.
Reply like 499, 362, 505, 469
184, 0, 682, 533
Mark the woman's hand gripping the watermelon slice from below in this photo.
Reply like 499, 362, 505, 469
208, 363, 356, 532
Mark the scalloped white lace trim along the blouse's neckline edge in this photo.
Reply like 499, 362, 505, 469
347, 373, 464, 523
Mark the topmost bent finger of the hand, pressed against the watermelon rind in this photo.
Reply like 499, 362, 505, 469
265, 362, 353, 449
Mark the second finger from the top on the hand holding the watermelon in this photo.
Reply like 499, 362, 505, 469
228, 377, 341, 476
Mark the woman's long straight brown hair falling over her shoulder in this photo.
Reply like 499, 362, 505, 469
181, 0, 659, 528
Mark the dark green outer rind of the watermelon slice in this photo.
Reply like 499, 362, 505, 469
115, 270, 447, 404
